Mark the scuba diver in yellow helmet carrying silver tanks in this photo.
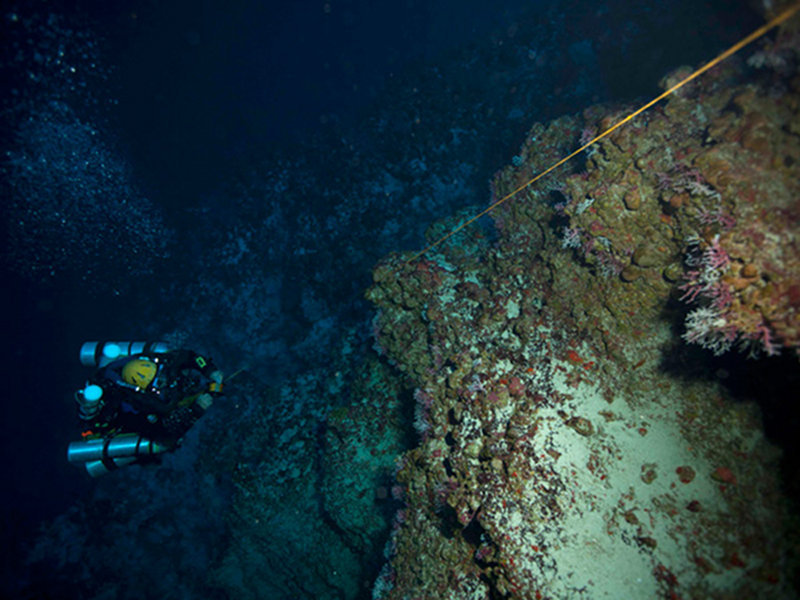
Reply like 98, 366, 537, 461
67, 342, 223, 477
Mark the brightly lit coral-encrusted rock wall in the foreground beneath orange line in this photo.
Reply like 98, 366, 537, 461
367, 16, 800, 599
